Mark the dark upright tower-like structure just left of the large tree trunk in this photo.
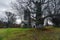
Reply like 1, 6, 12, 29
24, 10, 31, 28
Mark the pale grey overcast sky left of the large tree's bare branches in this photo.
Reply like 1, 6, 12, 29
0, 0, 11, 19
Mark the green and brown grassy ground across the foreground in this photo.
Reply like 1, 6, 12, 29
0, 27, 60, 40
